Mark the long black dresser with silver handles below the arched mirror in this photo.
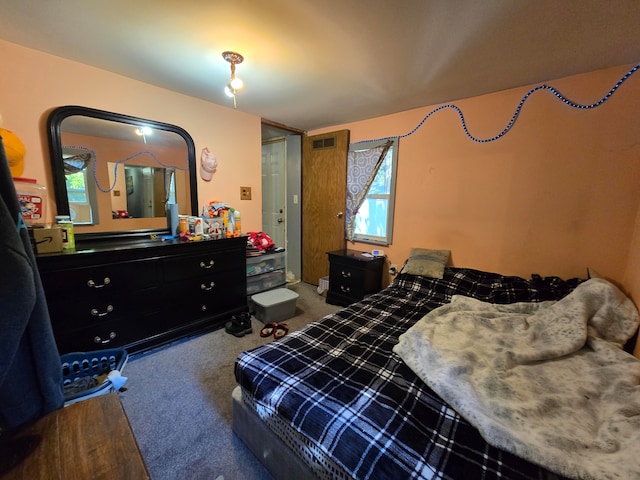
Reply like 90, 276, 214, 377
37, 237, 247, 354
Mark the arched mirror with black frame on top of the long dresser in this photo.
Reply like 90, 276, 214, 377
48, 106, 198, 239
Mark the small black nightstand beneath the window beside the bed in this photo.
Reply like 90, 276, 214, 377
327, 249, 385, 306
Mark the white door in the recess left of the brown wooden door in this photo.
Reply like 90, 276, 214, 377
262, 139, 287, 248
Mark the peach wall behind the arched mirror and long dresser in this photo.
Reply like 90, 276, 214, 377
0, 40, 262, 231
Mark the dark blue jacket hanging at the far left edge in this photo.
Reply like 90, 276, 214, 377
0, 133, 64, 431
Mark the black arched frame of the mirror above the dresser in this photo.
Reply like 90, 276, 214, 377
47, 105, 198, 241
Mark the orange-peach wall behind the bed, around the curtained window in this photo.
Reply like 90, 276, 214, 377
310, 66, 640, 294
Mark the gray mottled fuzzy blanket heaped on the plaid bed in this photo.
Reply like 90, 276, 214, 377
394, 279, 640, 480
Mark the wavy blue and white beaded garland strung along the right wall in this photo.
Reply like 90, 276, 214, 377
362, 63, 640, 143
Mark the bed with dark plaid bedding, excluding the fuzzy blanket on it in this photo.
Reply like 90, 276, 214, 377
233, 267, 640, 479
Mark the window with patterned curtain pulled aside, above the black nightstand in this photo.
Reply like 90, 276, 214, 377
346, 138, 398, 245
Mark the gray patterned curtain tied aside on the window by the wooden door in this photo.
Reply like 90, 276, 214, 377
345, 140, 393, 242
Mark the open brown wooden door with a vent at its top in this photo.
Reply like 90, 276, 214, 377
302, 130, 349, 285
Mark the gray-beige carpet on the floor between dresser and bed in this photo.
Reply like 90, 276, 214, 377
120, 283, 339, 480
